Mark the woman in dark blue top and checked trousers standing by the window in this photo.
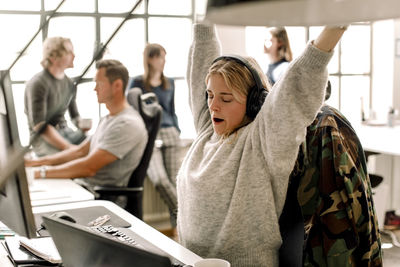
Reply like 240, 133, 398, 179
129, 43, 180, 227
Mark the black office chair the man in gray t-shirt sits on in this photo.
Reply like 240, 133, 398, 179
94, 88, 162, 219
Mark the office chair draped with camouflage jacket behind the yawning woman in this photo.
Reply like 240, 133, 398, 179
279, 106, 379, 267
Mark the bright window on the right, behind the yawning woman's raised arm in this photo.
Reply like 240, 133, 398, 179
246, 20, 394, 126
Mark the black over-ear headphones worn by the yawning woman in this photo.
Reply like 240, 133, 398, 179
209, 55, 268, 119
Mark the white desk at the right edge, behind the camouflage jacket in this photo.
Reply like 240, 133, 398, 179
353, 124, 400, 156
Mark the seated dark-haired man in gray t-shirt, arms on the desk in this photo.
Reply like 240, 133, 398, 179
25, 60, 148, 192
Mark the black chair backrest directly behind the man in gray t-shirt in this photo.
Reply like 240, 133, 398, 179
127, 88, 162, 187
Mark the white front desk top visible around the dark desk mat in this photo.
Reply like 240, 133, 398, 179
32, 200, 202, 266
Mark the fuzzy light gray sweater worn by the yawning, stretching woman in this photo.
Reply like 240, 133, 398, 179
177, 24, 332, 267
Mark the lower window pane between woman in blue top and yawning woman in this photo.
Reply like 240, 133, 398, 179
175, 79, 196, 139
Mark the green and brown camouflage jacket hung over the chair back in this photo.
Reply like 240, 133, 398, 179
291, 106, 382, 267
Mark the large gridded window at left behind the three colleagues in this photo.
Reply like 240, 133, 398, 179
0, 0, 206, 145
